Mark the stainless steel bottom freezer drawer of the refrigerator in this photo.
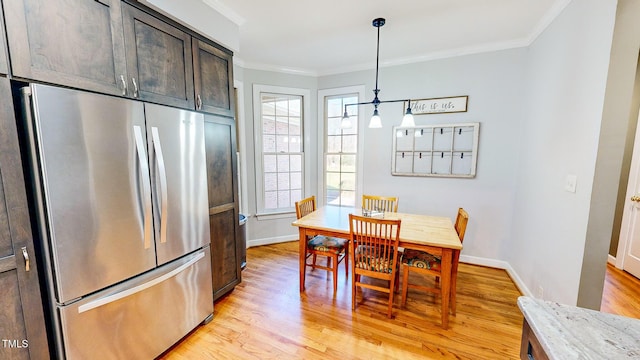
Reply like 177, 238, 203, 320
59, 247, 213, 359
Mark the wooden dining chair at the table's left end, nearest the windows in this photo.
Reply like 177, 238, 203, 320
295, 196, 349, 296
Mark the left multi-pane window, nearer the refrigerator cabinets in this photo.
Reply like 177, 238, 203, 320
254, 87, 308, 214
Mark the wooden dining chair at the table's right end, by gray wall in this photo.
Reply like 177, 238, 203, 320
401, 208, 469, 315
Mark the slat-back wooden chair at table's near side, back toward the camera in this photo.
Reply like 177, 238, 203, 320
349, 214, 400, 318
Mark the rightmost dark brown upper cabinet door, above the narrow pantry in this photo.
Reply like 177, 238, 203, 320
193, 38, 235, 117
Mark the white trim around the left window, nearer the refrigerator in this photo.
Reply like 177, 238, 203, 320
253, 84, 311, 220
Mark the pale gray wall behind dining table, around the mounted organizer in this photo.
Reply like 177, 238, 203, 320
318, 49, 526, 265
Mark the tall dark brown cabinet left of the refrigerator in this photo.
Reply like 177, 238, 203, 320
0, 77, 49, 359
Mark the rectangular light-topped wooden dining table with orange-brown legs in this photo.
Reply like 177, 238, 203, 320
292, 205, 462, 329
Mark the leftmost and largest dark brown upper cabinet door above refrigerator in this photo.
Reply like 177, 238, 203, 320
0, 0, 126, 95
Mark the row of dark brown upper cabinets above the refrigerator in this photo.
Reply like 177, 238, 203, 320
0, 0, 235, 117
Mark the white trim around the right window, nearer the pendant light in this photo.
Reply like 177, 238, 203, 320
316, 85, 366, 206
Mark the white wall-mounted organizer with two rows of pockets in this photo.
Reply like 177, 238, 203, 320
391, 123, 480, 178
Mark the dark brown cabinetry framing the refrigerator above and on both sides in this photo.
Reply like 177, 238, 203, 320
0, 0, 241, 359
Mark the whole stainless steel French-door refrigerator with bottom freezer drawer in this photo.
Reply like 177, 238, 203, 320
22, 85, 213, 359
